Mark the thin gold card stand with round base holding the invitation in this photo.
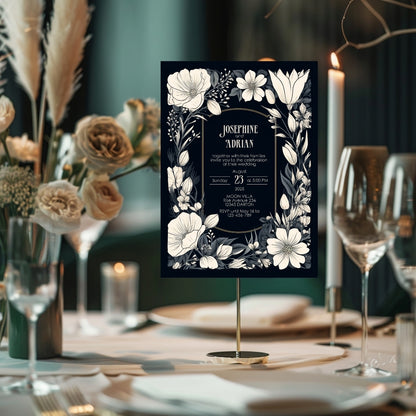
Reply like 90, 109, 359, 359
207, 277, 269, 365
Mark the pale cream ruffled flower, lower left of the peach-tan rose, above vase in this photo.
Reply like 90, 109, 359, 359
33, 180, 84, 234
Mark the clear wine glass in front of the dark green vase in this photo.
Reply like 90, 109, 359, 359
0, 217, 60, 394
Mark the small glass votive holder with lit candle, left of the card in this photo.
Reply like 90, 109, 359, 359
101, 261, 139, 326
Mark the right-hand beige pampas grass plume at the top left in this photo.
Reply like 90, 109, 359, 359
45, 0, 91, 127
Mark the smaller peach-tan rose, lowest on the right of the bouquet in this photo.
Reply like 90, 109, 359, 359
81, 175, 123, 221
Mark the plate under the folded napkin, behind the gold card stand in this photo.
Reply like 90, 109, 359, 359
149, 303, 360, 335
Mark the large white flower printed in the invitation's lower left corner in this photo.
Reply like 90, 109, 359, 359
168, 212, 205, 257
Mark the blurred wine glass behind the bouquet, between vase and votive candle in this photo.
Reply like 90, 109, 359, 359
65, 214, 108, 335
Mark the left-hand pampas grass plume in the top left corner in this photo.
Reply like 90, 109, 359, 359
0, 0, 43, 102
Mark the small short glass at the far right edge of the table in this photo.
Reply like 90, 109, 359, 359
396, 313, 414, 387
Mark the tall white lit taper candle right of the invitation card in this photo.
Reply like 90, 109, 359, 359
326, 53, 345, 288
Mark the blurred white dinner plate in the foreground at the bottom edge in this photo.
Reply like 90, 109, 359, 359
99, 370, 390, 416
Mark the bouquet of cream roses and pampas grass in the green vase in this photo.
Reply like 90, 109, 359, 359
0, 0, 160, 338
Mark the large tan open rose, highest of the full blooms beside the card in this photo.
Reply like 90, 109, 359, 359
75, 116, 134, 173
